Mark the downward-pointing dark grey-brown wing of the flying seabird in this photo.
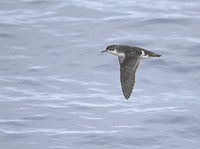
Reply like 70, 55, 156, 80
119, 56, 140, 99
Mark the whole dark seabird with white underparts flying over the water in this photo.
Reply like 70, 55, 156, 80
101, 45, 161, 100
